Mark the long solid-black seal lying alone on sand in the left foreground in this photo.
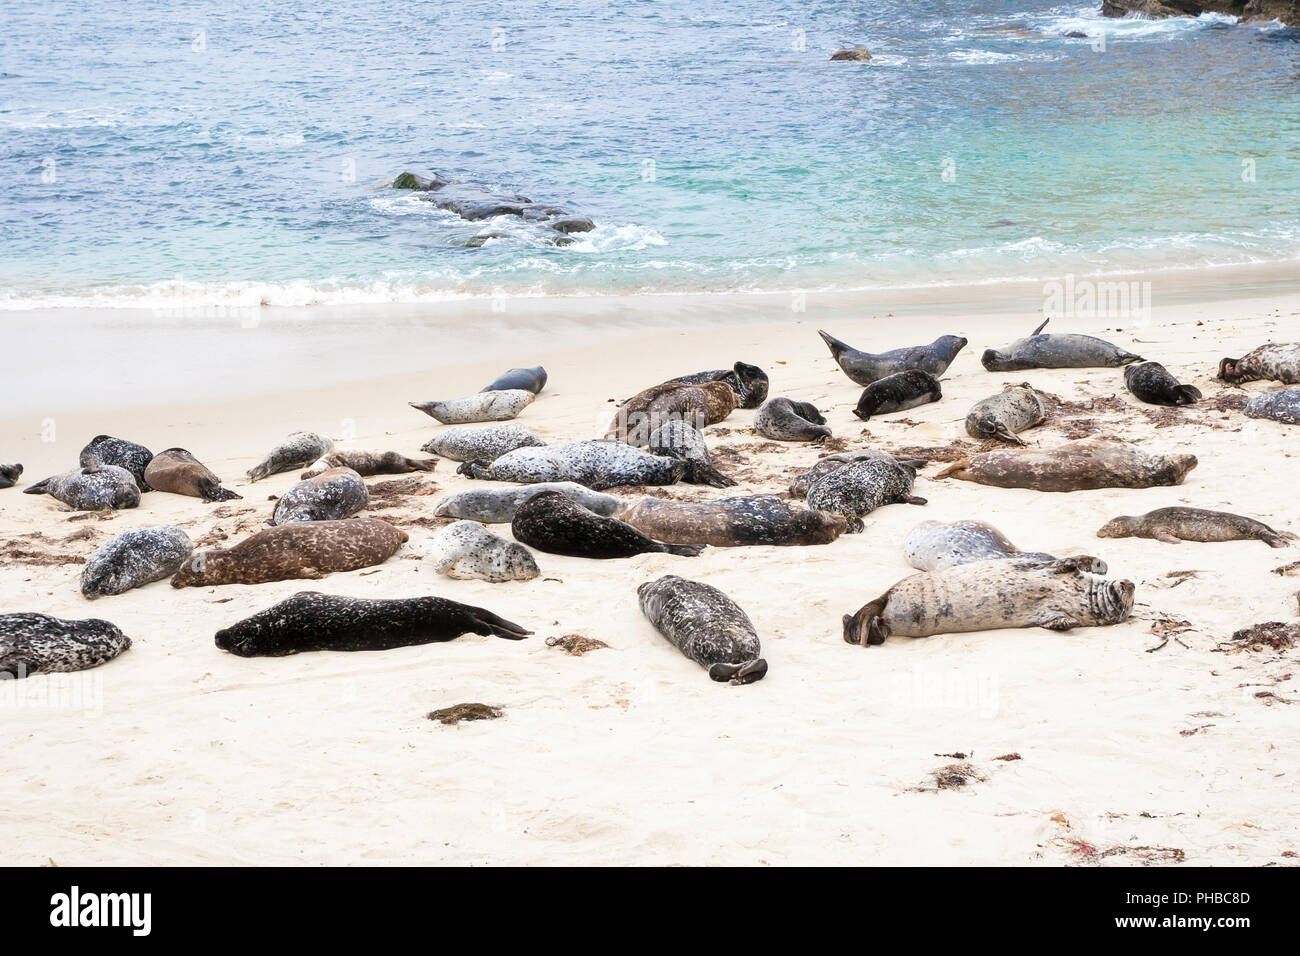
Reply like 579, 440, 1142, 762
216, 591, 532, 657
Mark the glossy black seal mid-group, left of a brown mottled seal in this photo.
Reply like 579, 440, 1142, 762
510, 492, 705, 558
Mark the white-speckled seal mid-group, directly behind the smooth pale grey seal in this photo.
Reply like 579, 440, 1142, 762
456, 440, 686, 492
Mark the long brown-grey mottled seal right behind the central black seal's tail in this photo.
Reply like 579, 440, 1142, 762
618, 494, 862, 548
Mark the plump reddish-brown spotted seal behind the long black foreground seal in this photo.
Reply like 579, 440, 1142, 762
172, 518, 407, 588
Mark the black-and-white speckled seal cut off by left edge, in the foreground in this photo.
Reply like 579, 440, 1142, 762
0, 613, 131, 679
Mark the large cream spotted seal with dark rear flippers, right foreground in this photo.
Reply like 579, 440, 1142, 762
844, 555, 1134, 646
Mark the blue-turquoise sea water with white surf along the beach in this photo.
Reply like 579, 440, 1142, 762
0, 0, 1300, 308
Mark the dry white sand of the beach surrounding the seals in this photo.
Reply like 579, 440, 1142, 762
0, 286, 1300, 865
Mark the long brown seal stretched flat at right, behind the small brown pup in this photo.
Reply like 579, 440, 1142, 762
935, 438, 1196, 492
